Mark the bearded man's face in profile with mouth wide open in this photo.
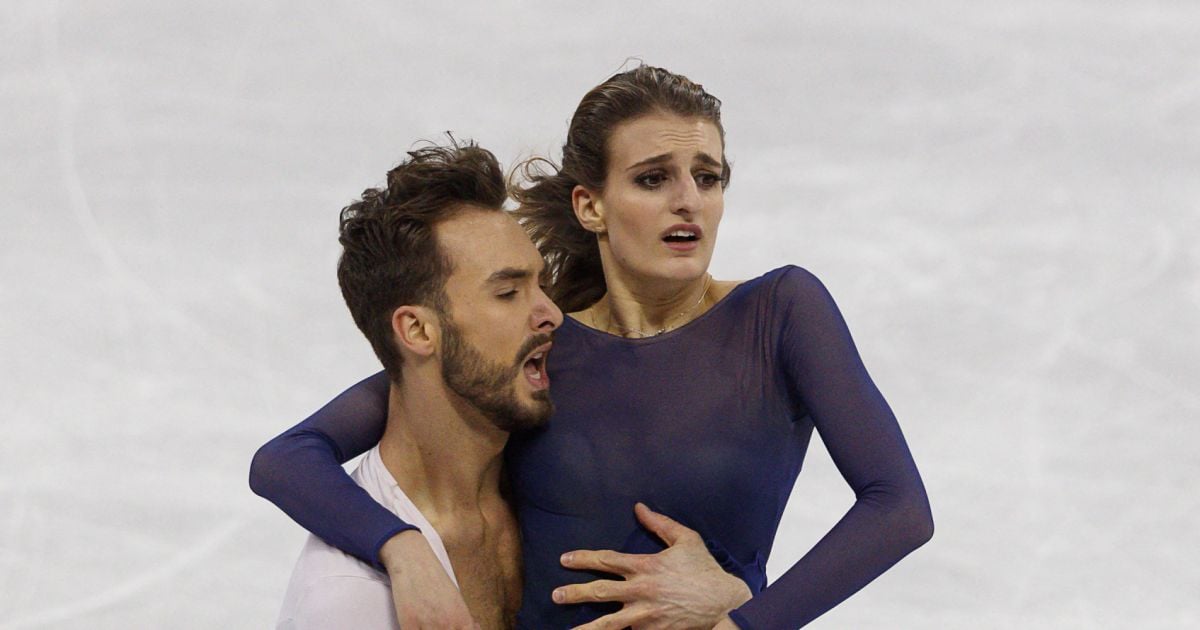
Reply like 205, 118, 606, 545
434, 210, 563, 431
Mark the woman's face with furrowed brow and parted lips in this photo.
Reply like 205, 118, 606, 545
578, 113, 725, 280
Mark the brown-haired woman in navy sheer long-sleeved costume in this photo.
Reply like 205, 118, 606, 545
252, 66, 932, 628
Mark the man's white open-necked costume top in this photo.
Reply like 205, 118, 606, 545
275, 445, 458, 630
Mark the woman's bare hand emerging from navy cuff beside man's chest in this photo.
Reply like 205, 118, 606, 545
379, 529, 479, 630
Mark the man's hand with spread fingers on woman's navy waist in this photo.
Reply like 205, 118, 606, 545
553, 503, 751, 630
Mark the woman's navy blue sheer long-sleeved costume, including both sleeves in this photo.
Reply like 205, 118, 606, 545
252, 266, 932, 629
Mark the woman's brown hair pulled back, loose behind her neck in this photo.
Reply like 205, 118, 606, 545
512, 65, 730, 313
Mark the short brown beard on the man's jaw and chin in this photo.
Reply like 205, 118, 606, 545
442, 313, 554, 432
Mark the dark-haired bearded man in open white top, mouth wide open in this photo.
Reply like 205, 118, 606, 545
278, 144, 563, 629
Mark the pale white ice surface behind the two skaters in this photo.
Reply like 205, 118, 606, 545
0, 0, 1200, 629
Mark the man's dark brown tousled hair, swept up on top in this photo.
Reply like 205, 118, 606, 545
337, 137, 508, 383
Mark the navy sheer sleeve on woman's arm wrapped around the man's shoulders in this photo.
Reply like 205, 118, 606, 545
250, 372, 416, 570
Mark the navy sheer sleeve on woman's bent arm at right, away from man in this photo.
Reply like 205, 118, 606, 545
731, 268, 934, 629
